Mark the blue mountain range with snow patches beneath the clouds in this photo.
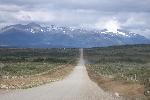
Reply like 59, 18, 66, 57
0, 23, 150, 47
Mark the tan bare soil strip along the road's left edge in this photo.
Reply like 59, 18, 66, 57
0, 64, 74, 89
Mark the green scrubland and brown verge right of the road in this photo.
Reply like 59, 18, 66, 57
84, 45, 150, 100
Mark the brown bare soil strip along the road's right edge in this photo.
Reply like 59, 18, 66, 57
87, 67, 146, 100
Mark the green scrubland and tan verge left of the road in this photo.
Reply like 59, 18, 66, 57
0, 48, 79, 88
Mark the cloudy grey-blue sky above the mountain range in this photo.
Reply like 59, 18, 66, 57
0, 0, 150, 38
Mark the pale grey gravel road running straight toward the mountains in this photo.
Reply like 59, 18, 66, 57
0, 49, 121, 100
